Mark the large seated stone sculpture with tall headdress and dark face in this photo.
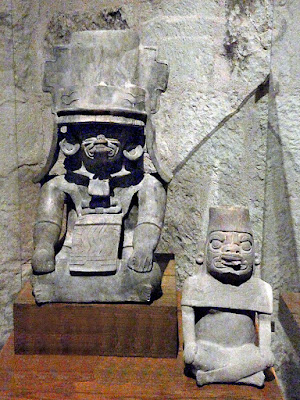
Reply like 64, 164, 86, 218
32, 30, 170, 303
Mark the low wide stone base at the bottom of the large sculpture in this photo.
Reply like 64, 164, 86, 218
32, 260, 163, 303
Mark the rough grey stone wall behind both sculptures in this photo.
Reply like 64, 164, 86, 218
0, 0, 300, 396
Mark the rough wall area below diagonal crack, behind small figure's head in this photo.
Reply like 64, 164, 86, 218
161, 92, 268, 284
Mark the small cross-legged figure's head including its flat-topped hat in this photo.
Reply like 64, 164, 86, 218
205, 207, 255, 285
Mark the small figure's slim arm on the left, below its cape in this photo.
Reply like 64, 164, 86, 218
181, 306, 197, 364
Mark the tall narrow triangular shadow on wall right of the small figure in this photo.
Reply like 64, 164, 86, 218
262, 99, 299, 300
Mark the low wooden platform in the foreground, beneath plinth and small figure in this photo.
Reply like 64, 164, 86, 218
0, 336, 282, 400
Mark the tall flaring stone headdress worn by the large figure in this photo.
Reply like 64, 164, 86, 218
36, 30, 171, 182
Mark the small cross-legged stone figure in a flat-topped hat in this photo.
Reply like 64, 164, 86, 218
182, 207, 274, 387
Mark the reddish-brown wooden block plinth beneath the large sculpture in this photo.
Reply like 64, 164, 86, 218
14, 260, 178, 358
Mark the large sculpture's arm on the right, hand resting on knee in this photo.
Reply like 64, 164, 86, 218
127, 175, 167, 272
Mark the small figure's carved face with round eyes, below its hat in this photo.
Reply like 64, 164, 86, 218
206, 231, 255, 284
